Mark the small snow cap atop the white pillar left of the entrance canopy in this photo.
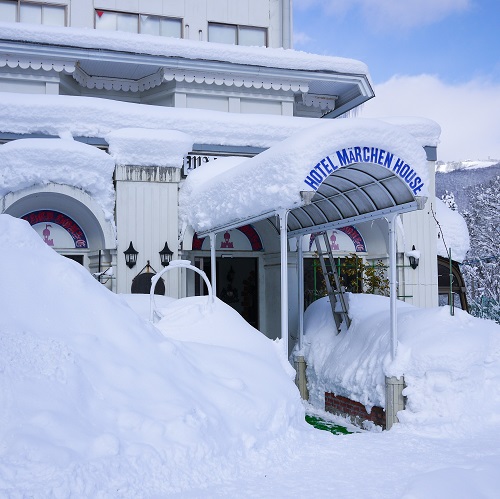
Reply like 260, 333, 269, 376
106, 128, 194, 168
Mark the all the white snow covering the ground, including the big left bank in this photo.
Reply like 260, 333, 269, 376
0, 215, 500, 499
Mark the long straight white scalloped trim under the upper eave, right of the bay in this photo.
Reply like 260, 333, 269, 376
163, 68, 309, 93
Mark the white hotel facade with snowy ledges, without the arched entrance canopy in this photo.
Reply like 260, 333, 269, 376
0, 0, 438, 344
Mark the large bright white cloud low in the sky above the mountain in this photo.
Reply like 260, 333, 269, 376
361, 75, 500, 161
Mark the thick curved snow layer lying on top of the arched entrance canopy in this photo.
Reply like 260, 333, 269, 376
179, 118, 428, 232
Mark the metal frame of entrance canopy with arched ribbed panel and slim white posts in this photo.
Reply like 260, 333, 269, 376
193, 163, 426, 358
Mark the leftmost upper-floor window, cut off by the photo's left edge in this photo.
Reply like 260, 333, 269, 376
0, 0, 66, 26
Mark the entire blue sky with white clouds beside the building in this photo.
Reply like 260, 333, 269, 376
294, 0, 500, 161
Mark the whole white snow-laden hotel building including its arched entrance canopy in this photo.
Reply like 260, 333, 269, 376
0, 0, 462, 372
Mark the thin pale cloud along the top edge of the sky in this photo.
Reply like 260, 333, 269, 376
295, 0, 471, 31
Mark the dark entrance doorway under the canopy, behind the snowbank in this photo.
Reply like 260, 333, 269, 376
195, 257, 259, 328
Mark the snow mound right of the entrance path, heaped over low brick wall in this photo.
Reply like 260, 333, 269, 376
304, 294, 500, 435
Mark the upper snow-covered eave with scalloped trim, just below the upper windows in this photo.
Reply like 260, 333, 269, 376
0, 23, 374, 117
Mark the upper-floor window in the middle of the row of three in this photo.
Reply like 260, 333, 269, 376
95, 10, 182, 38
